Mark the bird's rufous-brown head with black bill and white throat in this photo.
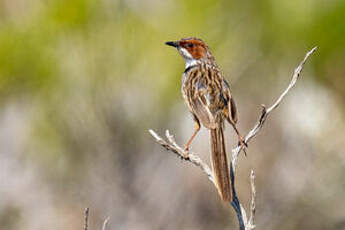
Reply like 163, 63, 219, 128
165, 37, 214, 67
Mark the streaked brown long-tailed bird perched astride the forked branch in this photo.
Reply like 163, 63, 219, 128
165, 37, 244, 201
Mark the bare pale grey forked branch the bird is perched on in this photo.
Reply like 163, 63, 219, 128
149, 47, 317, 230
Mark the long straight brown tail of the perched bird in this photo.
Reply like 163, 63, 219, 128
210, 125, 232, 202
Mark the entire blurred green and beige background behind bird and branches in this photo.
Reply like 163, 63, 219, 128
0, 0, 345, 230
